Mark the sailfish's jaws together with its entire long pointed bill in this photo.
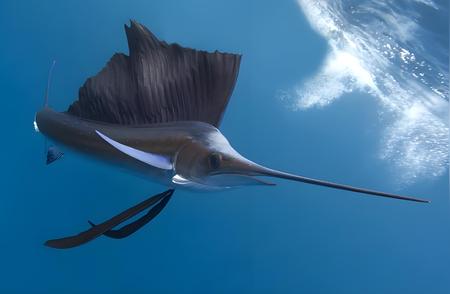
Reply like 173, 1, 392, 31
211, 160, 430, 203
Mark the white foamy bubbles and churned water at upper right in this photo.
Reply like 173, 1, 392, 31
283, 0, 449, 182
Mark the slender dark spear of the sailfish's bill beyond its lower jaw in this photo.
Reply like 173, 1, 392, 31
264, 169, 430, 203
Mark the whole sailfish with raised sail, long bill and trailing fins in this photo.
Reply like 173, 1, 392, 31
34, 21, 428, 249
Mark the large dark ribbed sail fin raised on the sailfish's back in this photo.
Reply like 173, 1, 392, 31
68, 21, 241, 126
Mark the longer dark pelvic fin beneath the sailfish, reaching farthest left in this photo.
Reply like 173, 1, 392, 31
45, 189, 174, 249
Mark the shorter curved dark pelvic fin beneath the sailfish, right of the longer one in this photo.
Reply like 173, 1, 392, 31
88, 194, 172, 239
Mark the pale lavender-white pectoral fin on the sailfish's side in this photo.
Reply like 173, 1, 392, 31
95, 130, 173, 170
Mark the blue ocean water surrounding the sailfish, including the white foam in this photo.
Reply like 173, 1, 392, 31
0, 0, 450, 293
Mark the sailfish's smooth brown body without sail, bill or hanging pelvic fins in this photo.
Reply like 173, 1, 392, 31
36, 108, 256, 189
